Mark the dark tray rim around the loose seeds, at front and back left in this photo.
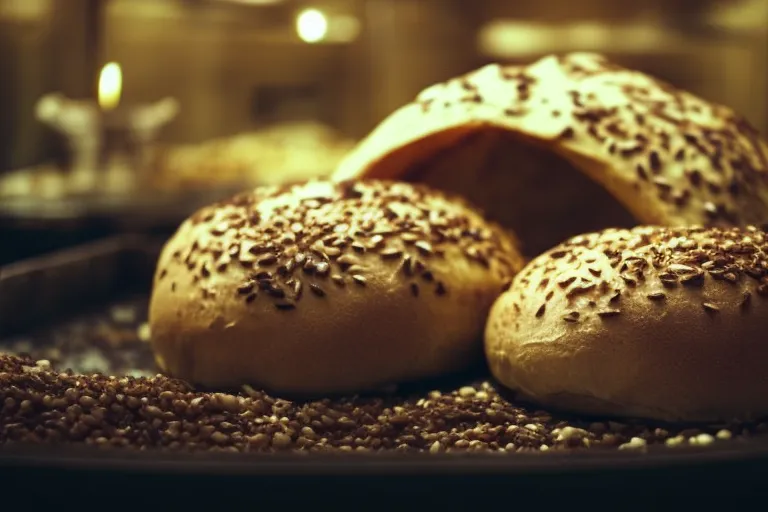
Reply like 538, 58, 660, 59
0, 236, 768, 504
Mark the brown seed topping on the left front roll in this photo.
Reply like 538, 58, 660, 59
176, 180, 523, 309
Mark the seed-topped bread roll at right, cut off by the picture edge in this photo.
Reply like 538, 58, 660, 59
485, 226, 768, 421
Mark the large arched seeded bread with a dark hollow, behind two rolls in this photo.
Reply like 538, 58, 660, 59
334, 53, 768, 257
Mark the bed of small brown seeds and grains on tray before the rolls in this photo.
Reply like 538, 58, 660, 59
0, 296, 768, 453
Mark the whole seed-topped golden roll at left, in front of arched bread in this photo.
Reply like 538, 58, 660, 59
149, 181, 523, 394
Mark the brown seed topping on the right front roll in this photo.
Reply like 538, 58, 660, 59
516, 226, 768, 323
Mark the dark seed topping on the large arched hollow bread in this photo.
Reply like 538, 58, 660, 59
408, 52, 768, 235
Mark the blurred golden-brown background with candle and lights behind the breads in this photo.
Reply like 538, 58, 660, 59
0, 0, 768, 264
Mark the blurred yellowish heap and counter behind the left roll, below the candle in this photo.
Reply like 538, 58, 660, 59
0, 122, 354, 229
